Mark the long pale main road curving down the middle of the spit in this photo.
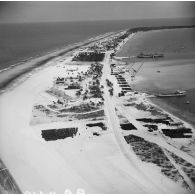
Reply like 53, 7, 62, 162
102, 52, 170, 193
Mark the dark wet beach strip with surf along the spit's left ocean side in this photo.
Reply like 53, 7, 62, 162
0, 30, 122, 93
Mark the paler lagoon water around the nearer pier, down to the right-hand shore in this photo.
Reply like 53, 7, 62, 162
134, 59, 195, 126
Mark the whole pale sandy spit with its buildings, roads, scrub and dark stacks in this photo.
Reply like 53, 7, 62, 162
0, 27, 195, 193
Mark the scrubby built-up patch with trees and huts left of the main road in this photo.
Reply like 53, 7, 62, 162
31, 63, 104, 124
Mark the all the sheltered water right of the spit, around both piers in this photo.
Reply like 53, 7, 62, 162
118, 28, 195, 127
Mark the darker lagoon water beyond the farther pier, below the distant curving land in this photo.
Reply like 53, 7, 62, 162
117, 28, 195, 59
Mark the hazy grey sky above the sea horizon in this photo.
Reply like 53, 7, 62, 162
0, 1, 195, 23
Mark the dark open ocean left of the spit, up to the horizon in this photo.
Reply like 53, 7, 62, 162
0, 19, 194, 70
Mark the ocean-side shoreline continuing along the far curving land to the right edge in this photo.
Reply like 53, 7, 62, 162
0, 25, 195, 92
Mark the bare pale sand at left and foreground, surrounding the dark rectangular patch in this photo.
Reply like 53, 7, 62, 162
0, 32, 190, 193
